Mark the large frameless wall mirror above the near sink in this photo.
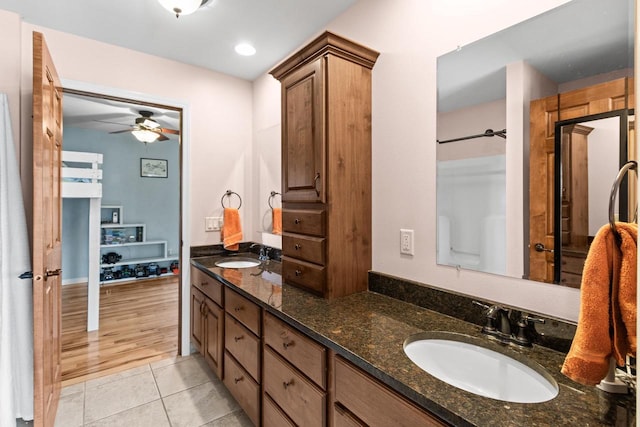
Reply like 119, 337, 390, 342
436, 0, 635, 287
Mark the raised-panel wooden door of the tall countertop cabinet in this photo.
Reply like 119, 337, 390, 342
282, 58, 326, 202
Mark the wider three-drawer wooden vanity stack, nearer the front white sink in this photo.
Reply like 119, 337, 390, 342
263, 313, 327, 427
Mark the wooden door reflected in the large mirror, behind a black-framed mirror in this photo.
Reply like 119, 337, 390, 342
529, 78, 633, 283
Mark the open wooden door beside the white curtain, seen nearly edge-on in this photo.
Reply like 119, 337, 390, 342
32, 32, 62, 426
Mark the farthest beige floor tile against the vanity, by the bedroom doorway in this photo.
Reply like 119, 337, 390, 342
153, 357, 213, 397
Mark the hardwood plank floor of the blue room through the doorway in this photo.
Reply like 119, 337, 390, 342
62, 277, 179, 386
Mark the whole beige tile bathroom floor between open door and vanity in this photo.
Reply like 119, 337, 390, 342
18, 355, 253, 427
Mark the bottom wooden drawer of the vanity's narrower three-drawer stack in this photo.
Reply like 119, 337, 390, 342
223, 352, 260, 426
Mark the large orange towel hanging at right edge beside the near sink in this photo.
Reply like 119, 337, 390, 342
562, 223, 638, 385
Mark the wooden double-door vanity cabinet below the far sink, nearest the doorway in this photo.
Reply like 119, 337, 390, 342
191, 267, 224, 378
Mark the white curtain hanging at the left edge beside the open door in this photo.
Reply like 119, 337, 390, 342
0, 94, 33, 427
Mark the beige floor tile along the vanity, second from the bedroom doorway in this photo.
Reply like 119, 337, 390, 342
162, 381, 239, 427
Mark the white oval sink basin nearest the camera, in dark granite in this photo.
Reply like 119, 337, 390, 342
404, 332, 558, 403
